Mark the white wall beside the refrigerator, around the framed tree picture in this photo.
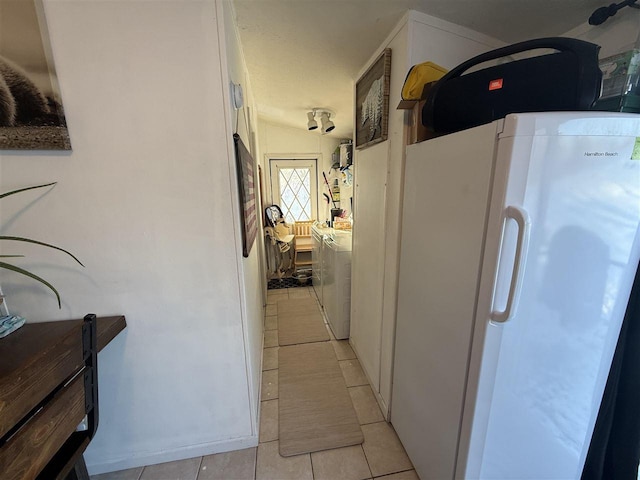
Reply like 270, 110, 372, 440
351, 11, 502, 412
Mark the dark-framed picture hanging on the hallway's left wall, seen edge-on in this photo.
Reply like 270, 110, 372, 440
233, 133, 258, 258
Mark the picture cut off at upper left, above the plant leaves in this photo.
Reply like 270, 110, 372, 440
0, 0, 71, 150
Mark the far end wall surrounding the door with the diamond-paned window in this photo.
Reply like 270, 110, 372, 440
258, 119, 350, 221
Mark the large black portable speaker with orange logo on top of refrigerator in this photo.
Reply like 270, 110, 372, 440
422, 37, 602, 134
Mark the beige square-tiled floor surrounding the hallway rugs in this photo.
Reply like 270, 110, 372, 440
91, 287, 418, 480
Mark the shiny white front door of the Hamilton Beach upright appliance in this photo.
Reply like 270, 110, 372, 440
465, 118, 640, 480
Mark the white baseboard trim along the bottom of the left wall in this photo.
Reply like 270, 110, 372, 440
87, 436, 258, 475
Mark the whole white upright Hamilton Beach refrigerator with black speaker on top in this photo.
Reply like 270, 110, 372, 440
391, 112, 640, 480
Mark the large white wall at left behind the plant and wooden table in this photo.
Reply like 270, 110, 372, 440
0, 0, 259, 473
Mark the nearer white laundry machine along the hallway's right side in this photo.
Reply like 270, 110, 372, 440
322, 230, 351, 340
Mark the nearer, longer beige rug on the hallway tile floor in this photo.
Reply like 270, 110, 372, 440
278, 342, 364, 457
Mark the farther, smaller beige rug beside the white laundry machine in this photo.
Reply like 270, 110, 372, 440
278, 299, 329, 347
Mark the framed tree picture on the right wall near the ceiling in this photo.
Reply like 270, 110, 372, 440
356, 48, 391, 149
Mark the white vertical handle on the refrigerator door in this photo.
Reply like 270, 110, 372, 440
491, 205, 531, 323
